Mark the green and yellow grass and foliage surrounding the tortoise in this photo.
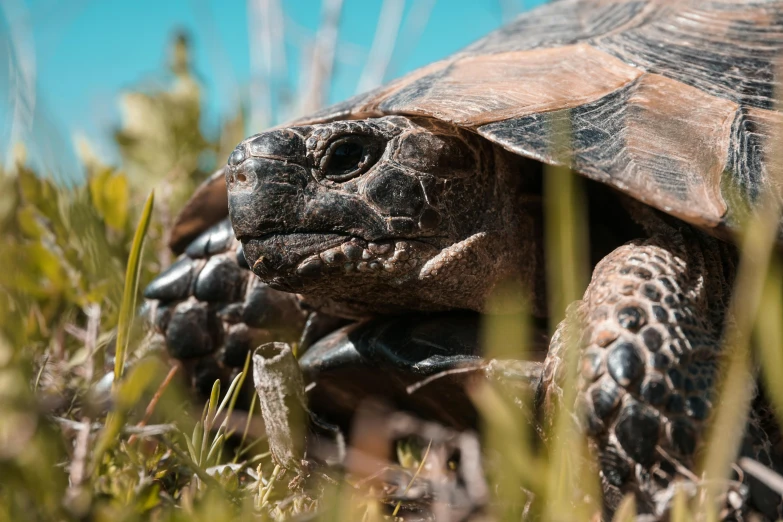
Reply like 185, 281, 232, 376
0, 22, 783, 522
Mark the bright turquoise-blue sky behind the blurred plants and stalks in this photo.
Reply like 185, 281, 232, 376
0, 0, 543, 176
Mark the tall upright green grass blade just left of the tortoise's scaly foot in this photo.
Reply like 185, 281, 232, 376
113, 191, 155, 387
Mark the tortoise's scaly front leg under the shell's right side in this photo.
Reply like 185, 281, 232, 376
543, 232, 733, 508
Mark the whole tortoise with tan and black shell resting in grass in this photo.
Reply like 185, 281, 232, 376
145, 0, 783, 516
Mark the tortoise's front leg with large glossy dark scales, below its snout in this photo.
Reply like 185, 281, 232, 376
144, 219, 306, 405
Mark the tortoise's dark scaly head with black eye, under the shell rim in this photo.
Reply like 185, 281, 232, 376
226, 116, 529, 312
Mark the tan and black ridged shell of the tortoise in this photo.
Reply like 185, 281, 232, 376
171, 0, 783, 250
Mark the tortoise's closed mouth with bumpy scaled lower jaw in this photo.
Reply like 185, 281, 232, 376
241, 232, 440, 291
